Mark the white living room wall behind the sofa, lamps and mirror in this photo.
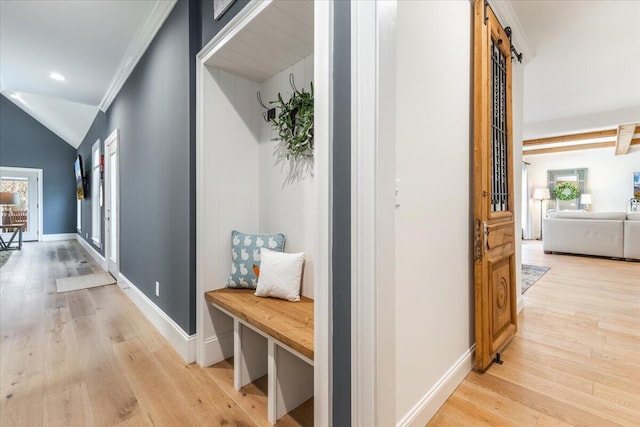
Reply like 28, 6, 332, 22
524, 145, 640, 236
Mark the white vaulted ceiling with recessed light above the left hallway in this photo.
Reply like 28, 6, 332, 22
0, 0, 175, 147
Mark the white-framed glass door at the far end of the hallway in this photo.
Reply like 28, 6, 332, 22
0, 168, 40, 241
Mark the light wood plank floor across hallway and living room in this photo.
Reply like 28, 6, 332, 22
0, 242, 640, 426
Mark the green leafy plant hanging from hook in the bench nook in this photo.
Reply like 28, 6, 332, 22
270, 76, 313, 160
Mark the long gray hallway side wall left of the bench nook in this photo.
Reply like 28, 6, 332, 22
78, 0, 200, 334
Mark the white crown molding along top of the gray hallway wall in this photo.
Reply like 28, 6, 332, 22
98, 0, 178, 111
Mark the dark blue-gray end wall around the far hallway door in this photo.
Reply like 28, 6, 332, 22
0, 95, 76, 234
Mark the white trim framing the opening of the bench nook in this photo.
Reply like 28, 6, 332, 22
196, 0, 333, 426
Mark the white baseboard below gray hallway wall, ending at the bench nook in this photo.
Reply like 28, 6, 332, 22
118, 273, 196, 363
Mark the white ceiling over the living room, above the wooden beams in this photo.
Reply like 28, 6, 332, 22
511, 0, 640, 139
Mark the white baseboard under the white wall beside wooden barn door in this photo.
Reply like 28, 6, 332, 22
397, 344, 476, 427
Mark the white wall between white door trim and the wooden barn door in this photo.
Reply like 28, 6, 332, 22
395, 1, 474, 425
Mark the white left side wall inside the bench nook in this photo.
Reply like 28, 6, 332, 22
198, 68, 261, 350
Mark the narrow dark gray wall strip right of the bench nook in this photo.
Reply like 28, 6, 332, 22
332, 0, 351, 426
